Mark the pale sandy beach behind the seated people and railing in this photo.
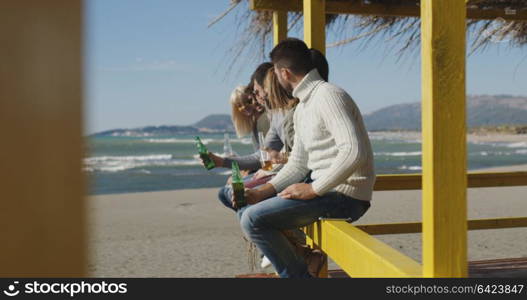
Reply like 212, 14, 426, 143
87, 165, 527, 277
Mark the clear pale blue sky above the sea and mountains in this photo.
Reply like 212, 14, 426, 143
85, 0, 527, 133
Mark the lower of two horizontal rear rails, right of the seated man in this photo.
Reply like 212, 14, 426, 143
355, 217, 527, 235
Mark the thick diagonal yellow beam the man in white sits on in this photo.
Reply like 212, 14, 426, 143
307, 220, 422, 277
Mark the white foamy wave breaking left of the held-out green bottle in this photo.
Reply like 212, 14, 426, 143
83, 154, 201, 174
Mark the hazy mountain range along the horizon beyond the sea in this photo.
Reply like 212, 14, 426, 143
92, 95, 527, 136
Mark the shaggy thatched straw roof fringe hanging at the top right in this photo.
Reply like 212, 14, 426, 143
211, 0, 527, 68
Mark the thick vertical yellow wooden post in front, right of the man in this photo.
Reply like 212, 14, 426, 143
421, 0, 467, 277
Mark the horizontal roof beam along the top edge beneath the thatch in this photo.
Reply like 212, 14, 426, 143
250, 0, 527, 21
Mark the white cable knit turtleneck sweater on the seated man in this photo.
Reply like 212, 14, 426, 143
269, 69, 375, 201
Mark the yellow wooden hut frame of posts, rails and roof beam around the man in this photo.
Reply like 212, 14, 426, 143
251, 0, 527, 277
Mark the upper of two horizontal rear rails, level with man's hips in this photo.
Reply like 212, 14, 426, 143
374, 171, 527, 191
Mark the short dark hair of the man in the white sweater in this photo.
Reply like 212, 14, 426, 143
270, 38, 313, 75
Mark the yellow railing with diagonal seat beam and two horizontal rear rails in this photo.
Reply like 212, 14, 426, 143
305, 172, 527, 277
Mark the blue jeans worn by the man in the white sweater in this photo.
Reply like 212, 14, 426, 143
237, 192, 369, 278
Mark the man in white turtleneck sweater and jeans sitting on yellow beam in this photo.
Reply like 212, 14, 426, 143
234, 38, 375, 277
